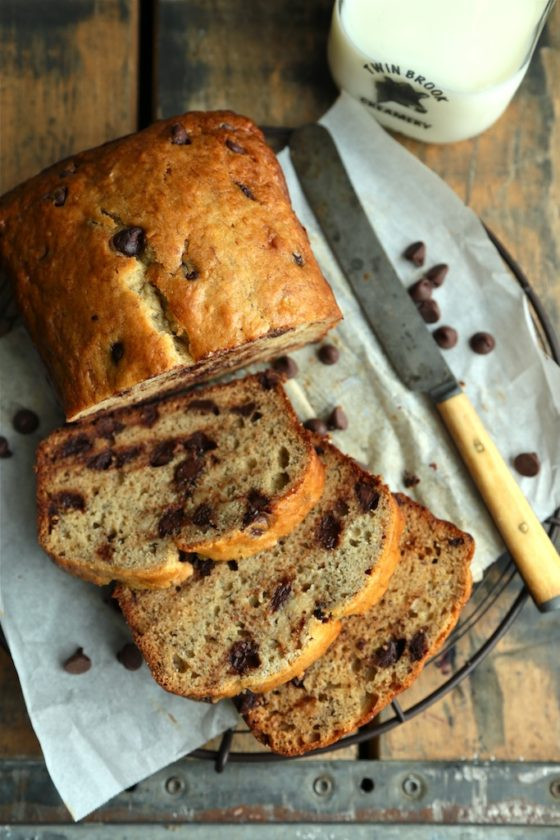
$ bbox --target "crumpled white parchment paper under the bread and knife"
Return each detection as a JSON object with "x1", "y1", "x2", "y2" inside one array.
[{"x1": 0, "y1": 96, "x2": 560, "y2": 819}]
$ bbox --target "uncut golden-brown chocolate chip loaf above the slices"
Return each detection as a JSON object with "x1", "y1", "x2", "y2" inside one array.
[{"x1": 0, "y1": 111, "x2": 341, "y2": 420}]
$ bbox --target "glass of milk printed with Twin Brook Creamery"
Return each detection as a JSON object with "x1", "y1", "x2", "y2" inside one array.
[{"x1": 328, "y1": 0, "x2": 554, "y2": 143}]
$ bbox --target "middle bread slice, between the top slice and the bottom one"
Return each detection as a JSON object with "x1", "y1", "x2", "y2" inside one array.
[{"x1": 115, "y1": 443, "x2": 401, "y2": 699}]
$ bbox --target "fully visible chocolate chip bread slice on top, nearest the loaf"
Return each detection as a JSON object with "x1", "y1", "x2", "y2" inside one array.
[{"x1": 36, "y1": 371, "x2": 324, "y2": 587}]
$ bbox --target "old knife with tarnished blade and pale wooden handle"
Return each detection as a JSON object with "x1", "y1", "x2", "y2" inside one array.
[{"x1": 290, "y1": 124, "x2": 560, "y2": 612}]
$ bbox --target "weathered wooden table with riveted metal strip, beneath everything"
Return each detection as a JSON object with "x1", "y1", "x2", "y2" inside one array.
[{"x1": 0, "y1": 0, "x2": 560, "y2": 838}]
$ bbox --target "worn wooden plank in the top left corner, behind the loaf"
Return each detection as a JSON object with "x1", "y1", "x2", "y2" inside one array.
[{"x1": 0, "y1": 0, "x2": 139, "y2": 193}]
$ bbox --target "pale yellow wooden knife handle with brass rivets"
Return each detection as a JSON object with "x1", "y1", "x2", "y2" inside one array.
[{"x1": 437, "y1": 394, "x2": 560, "y2": 612}]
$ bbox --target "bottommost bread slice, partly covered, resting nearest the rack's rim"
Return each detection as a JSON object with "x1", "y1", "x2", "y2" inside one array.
[{"x1": 243, "y1": 494, "x2": 474, "y2": 755}]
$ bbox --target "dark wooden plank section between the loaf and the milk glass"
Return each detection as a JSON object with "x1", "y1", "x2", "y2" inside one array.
[{"x1": 156, "y1": 0, "x2": 336, "y2": 126}]
